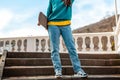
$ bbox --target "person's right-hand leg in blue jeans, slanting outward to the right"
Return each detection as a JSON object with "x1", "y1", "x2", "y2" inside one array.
[{"x1": 60, "y1": 26, "x2": 85, "y2": 74}]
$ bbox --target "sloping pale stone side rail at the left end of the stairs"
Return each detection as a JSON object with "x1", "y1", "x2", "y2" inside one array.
[{"x1": 0, "y1": 50, "x2": 7, "y2": 80}]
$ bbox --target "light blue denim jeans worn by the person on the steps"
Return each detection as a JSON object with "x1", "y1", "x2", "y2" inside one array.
[{"x1": 48, "y1": 26, "x2": 82, "y2": 72}]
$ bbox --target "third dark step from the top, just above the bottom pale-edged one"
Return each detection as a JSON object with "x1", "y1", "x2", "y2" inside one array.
[{"x1": 3, "y1": 66, "x2": 120, "y2": 77}]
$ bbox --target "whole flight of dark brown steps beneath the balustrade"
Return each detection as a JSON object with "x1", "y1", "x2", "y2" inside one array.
[{"x1": 2, "y1": 52, "x2": 120, "y2": 80}]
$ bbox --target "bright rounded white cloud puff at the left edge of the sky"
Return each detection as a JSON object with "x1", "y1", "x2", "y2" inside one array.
[{"x1": 0, "y1": 9, "x2": 13, "y2": 30}]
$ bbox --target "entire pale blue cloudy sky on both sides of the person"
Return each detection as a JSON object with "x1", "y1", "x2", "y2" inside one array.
[{"x1": 0, "y1": 0, "x2": 120, "y2": 38}]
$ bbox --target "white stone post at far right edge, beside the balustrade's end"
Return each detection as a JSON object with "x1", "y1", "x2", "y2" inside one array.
[{"x1": 115, "y1": 17, "x2": 120, "y2": 53}]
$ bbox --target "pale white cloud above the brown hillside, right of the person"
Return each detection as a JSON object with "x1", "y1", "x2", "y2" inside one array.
[{"x1": 72, "y1": 0, "x2": 114, "y2": 29}]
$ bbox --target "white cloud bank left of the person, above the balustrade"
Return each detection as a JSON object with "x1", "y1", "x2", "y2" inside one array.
[{"x1": 0, "y1": 9, "x2": 41, "y2": 37}]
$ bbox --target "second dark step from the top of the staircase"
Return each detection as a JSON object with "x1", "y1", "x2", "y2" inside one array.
[{"x1": 5, "y1": 58, "x2": 120, "y2": 66}]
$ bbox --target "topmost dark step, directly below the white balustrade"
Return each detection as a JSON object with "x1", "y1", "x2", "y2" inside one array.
[{"x1": 7, "y1": 52, "x2": 120, "y2": 59}]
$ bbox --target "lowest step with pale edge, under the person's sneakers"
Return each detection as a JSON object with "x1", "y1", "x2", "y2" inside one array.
[{"x1": 2, "y1": 74, "x2": 120, "y2": 80}]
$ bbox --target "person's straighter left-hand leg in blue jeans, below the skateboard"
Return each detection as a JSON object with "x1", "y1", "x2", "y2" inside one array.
[{"x1": 48, "y1": 26, "x2": 62, "y2": 75}]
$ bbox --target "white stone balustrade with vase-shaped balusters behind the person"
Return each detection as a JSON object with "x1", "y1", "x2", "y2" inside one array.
[{"x1": 0, "y1": 32, "x2": 116, "y2": 53}]
